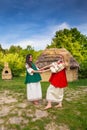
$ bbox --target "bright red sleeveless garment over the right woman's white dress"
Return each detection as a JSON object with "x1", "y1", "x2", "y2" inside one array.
[{"x1": 49, "y1": 69, "x2": 68, "y2": 88}]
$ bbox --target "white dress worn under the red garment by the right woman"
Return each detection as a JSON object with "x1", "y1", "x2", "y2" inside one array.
[{"x1": 46, "y1": 62, "x2": 65, "y2": 103}]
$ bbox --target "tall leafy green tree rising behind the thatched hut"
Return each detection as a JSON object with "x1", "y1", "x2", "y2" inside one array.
[{"x1": 47, "y1": 28, "x2": 87, "y2": 77}]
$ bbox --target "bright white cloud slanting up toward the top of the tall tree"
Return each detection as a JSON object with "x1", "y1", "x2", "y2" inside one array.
[{"x1": 15, "y1": 23, "x2": 70, "y2": 50}]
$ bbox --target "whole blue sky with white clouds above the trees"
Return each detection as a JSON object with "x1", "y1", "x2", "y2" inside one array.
[{"x1": 0, "y1": 0, "x2": 87, "y2": 50}]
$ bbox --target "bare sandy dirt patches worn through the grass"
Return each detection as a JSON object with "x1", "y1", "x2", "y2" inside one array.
[{"x1": 0, "y1": 87, "x2": 87, "y2": 130}]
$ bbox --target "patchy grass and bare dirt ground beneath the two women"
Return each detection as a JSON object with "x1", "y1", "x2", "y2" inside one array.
[{"x1": 0, "y1": 77, "x2": 87, "y2": 130}]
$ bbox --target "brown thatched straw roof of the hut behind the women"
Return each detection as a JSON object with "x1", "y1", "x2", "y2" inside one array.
[{"x1": 36, "y1": 48, "x2": 79, "y2": 69}]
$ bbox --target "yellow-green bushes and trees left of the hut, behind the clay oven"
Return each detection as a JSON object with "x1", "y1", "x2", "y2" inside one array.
[{"x1": 0, "y1": 46, "x2": 41, "y2": 77}]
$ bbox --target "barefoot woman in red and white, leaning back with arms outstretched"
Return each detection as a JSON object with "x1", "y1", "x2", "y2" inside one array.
[{"x1": 43, "y1": 55, "x2": 67, "y2": 110}]
